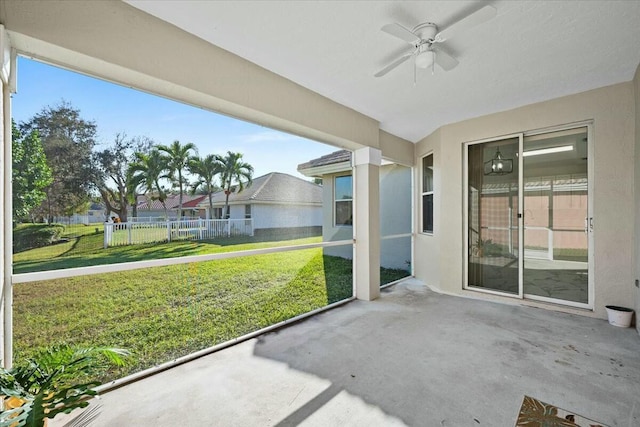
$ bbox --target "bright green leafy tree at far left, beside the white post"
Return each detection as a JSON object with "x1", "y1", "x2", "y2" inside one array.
[{"x1": 11, "y1": 120, "x2": 53, "y2": 220}]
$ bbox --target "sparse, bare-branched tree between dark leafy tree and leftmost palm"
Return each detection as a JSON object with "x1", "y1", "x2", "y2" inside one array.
[{"x1": 94, "y1": 134, "x2": 151, "y2": 222}]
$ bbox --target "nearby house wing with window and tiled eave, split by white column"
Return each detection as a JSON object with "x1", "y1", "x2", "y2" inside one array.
[{"x1": 298, "y1": 150, "x2": 411, "y2": 270}]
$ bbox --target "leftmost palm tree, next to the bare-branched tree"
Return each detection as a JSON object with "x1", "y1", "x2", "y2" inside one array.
[{"x1": 128, "y1": 149, "x2": 167, "y2": 217}]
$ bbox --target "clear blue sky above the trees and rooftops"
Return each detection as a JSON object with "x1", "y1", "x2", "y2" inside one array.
[{"x1": 12, "y1": 57, "x2": 338, "y2": 178}]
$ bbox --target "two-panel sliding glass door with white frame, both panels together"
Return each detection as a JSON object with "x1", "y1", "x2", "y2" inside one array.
[{"x1": 465, "y1": 126, "x2": 593, "y2": 307}]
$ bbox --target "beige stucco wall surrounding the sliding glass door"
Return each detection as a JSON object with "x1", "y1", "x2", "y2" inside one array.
[{"x1": 415, "y1": 82, "x2": 636, "y2": 318}]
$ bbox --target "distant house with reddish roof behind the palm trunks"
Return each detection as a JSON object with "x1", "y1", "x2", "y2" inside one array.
[{"x1": 129, "y1": 194, "x2": 207, "y2": 221}]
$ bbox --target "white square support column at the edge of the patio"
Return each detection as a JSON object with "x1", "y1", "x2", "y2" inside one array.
[{"x1": 354, "y1": 147, "x2": 382, "y2": 301}]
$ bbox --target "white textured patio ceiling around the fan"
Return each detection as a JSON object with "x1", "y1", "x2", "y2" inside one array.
[{"x1": 127, "y1": 0, "x2": 640, "y2": 142}]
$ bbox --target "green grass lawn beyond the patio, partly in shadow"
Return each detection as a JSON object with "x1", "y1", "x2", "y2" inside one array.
[{"x1": 14, "y1": 224, "x2": 407, "y2": 381}]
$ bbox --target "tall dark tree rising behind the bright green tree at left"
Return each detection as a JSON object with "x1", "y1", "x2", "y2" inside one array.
[{"x1": 18, "y1": 101, "x2": 97, "y2": 222}]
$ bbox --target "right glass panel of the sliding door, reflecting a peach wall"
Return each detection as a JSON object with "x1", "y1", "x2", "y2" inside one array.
[{"x1": 523, "y1": 127, "x2": 589, "y2": 304}]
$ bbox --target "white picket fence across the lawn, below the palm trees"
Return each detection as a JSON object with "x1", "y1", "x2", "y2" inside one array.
[{"x1": 104, "y1": 218, "x2": 253, "y2": 248}]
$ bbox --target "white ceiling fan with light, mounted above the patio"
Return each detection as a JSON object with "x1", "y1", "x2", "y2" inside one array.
[{"x1": 374, "y1": 5, "x2": 497, "y2": 77}]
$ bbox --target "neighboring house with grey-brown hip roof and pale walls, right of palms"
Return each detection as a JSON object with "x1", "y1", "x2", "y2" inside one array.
[{"x1": 197, "y1": 172, "x2": 322, "y2": 235}]
